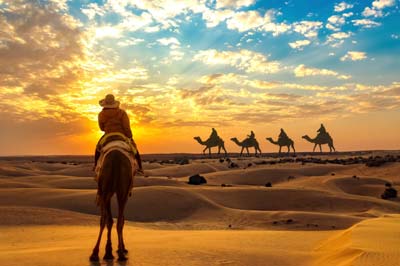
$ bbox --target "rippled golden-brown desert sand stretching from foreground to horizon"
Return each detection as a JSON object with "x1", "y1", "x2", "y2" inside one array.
[{"x1": 0, "y1": 152, "x2": 400, "y2": 266}]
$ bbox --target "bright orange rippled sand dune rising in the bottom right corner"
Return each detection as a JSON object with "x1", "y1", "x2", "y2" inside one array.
[{"x1": 315, "y1": 215, "x2": 400, "y2": 266}]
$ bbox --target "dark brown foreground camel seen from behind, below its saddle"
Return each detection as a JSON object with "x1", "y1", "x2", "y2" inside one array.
[{"x1": 90, "y1": 150, "x2": 138, "y2": 262}]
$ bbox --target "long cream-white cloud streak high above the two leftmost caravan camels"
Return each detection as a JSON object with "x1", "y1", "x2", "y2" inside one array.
[{"x1": 193, "y1": 49, "x2": 280, "y2": 73}]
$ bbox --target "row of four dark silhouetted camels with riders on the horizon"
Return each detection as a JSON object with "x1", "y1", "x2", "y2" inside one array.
[{"x1": 194, "y1": 124, "x2": 336, "y2": 156}]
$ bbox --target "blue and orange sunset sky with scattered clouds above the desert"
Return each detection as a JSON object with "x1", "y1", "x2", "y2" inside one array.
[{"x1": 0, "y1": 0, "x2": 400, "y2": 155}]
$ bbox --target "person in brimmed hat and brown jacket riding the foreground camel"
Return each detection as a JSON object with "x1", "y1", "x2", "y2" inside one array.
[{"x1": 94, "y1": 94, "x2": 143, "y2": 173}]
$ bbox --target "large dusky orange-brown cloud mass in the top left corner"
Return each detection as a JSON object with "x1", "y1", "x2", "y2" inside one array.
[{"x1": 0, "y1": 1, "x2": 85, "y2": 97}]
